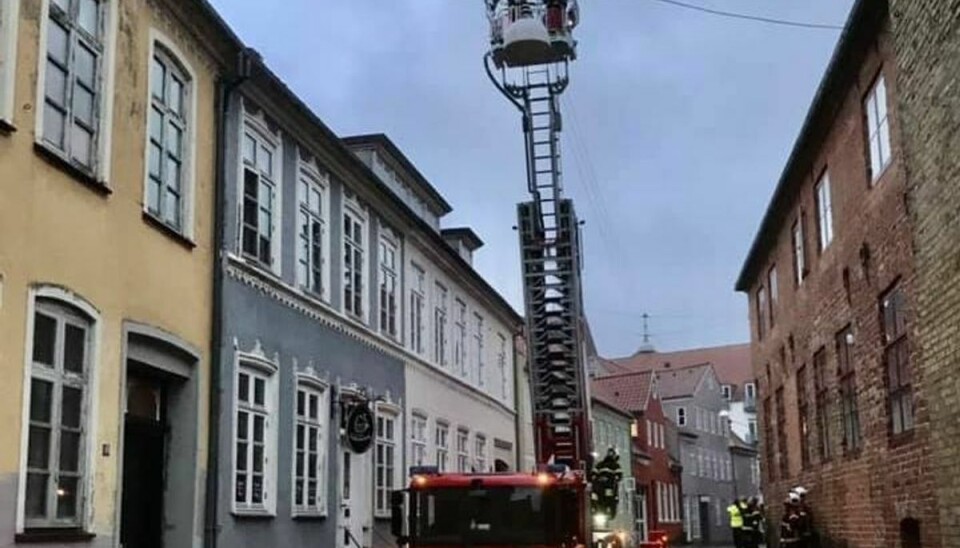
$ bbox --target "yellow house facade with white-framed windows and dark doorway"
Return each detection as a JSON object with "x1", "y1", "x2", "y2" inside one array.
[{"x1": 0, "y1": 0, "x2": 232, "y2": 547}]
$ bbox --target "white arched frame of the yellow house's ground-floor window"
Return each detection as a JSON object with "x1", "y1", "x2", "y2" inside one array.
[{"x1": 15, "y1": 294, "x2": 102, "y2": 534}]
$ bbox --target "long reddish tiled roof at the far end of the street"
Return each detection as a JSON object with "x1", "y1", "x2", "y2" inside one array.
[{"x1": 606, "y1": 343, "x2": 754, "y2": 386}]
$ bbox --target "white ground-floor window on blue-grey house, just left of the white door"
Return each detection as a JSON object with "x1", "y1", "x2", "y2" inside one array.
[{"x1": 292, "y1": 380, "x2": 329, "y2": 515}]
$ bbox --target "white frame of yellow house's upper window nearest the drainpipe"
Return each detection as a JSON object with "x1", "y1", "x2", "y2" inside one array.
[{"x1": 143, "y1": 32, "x2": 197, "y2": 235}]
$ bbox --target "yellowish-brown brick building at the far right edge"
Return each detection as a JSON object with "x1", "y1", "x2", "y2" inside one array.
[{"x1": 891, "y1": 0, "x2": 960, "y2": 546}]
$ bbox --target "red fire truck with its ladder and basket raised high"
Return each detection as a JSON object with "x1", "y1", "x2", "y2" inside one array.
[{"x1": 391, "y1": 0, "x2": 659, "y2": 548}]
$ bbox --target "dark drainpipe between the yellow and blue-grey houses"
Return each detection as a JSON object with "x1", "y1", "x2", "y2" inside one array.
[{"x1": 203, "y1": 48, "x2": 258, "y2": 548}]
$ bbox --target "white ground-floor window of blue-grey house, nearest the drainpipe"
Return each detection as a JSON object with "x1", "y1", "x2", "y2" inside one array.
[{"x1": 233, "y1": 360, "x2": 275, "y2": 513}]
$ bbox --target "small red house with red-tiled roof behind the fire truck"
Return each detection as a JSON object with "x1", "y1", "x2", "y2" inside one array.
[{"x1": 591, "y1": 372, "x2": 683, "y2": 539}]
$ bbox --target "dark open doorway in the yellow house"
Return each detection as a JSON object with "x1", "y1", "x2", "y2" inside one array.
[{"x1": 120, "y1": 371, "x2": 166, "y2": 548}]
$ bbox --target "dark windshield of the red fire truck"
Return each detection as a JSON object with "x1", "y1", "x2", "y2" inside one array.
[{"x1": 413, "y1": 486, "x2": 577, "y2": 546}]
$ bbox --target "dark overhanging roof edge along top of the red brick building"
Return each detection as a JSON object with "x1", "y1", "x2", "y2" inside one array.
[{"x1": 735, "y1": 0, "x2": 888, "y2": 291}]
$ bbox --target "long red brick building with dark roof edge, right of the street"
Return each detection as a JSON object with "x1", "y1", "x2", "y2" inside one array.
[{"x1": 736, "y1": 0, "x2": 940, "y2": 547}]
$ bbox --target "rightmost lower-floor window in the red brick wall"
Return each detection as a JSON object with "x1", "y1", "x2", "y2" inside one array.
[{"x1": 880, "y1": 286, "x2": 913, "y2": 434}]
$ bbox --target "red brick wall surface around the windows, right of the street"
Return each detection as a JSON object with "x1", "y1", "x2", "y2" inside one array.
[{"x1": 750, "y1": 10, "x2": 940, "y2": 548}]
